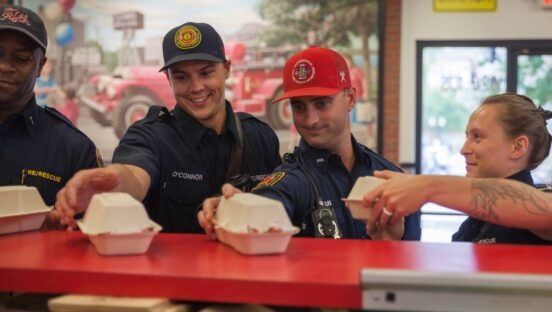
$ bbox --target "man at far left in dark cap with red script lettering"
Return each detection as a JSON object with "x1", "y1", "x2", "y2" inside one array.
[{"x1": 0, "y1": 5, "x2": 101, "y2": 219}]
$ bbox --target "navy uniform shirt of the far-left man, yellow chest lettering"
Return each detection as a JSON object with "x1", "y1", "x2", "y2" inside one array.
[{"x1": 0, "y1": 96, "x2": 101, "y2": 206}]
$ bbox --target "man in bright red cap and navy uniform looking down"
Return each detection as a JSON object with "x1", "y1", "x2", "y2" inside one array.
[{"x1": 198, "y1": 47, "x2": 421, "y2": 240}]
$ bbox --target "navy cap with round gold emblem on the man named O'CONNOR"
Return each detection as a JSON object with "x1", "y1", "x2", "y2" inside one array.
[{"x1": 159, "y1": 22, "x2": 226, "y2": 71}]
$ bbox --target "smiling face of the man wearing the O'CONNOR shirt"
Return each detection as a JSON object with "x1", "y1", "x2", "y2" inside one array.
[{"x1": 167, "y1": 61, "x2": 230, "y2": 133}]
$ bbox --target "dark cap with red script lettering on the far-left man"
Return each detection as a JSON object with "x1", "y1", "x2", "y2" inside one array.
[{"x1": 0, "y1": 5, "x2": 48, "y2": 51}]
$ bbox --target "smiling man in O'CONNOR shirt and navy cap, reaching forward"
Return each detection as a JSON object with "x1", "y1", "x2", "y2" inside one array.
[{"x1": 56, "y1": 22, "x2": 281, "y2": 233}]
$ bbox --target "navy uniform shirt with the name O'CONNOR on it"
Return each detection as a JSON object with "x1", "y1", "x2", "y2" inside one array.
[{"x1": 113, "y1": 102, "x2": 281, "y2": 233}]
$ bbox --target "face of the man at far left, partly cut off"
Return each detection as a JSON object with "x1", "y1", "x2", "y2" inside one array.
[{"x1": 0, "y1": 30, "x2": 45, "y2": 120}]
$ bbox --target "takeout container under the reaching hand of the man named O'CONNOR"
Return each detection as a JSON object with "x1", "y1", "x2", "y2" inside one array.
[{"x1": 77, "y1": 193, "x2": 161, "y2": 255}]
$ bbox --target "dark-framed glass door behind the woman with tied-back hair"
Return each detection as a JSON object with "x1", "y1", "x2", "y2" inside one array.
[{"x1": 415, "y1": 40, "x2": 552, "y2": 241}]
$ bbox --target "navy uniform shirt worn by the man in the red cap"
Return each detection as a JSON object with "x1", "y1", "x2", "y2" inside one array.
[{"x1": 254, "y1": 136, "x2": 422, "y2": 240}]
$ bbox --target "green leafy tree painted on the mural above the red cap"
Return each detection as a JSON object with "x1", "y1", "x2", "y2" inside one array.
[{"x1": 258, "y1": 0, "x2": 379, "y2": 99}]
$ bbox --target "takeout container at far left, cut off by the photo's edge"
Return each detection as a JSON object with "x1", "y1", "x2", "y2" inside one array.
[{"x1": 0, "y1": 185, "x2": 50, "y2": 234}]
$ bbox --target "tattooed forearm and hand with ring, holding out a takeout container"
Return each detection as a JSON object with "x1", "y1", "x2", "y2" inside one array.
[{"x1": 364, "y1": 171, "x2": 552, "y2": 238}]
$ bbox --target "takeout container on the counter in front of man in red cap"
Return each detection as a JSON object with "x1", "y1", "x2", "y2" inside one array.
[{"x1": 215, "y1": 193, "x2": 299, "y2": 255}]
